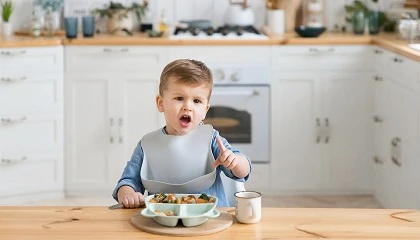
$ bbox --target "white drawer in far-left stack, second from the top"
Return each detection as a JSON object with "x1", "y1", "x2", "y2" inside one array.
[{"x1": 0, "y1": 73, "x2": 63, "y2": 114}]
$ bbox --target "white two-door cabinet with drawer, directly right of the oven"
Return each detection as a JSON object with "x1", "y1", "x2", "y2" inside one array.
[{"x1": 271, "y1": 46, "x2": 372, "y2": 193}]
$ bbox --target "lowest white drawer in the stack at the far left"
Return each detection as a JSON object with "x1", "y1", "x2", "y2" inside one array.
[{"x1": 0, "y1": 151, "x2": 63, "y2": 197}]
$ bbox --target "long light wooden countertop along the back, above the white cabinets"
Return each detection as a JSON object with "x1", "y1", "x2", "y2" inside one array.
[{"x1": 0, "y1": 32, "x2": 420, "y2": 61}]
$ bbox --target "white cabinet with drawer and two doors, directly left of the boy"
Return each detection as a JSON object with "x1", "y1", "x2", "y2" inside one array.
[{"x1": 66, "y1": 46, "x2": 165, "y2": 195}]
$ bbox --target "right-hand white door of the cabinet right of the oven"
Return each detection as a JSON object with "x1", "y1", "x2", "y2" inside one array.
[{"x1": 320, "y1": 72, "x2": 372, "y2": 192}]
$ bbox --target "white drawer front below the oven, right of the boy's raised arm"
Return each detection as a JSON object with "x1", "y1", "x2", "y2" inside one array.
[{"x1": 245, "y1": 163, "x2": 270, "y2": 191}]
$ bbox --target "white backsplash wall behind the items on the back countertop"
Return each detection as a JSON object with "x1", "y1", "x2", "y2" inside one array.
[{"x1": 5, "y1": 0, "x2": 404, "y2": 29}]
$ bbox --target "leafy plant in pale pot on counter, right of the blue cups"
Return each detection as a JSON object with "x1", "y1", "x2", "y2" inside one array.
[{"x1": 93, "y1": 1, "x2": 148, "y2": 35}]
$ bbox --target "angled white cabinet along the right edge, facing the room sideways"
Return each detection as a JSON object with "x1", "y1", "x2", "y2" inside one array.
[{"x1": 373, "y1": 48, "x2": 420, "y2": 208}]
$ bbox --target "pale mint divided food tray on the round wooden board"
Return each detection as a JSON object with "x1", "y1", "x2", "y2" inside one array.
[{"x1": 140, "y1": 194, "x2": 220, "y2": 227}]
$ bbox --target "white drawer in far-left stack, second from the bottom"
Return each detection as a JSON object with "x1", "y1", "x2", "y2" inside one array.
[{"x1": 0, "y1": 113, "x2": 63, "y2": 153}]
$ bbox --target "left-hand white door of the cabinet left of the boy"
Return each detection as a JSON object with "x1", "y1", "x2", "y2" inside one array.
[{"x1": 66, "y1": 74, "x2": 116, "y2": 192}]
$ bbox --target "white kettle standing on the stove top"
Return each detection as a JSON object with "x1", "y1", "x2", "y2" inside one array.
[{"x1": 225, "y1": 0, "x2": 255, "y2": 26}]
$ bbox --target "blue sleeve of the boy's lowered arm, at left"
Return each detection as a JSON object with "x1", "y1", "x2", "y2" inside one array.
[{"x1": 112, "y1": 142, "x2": 144, "y2": 201}]
